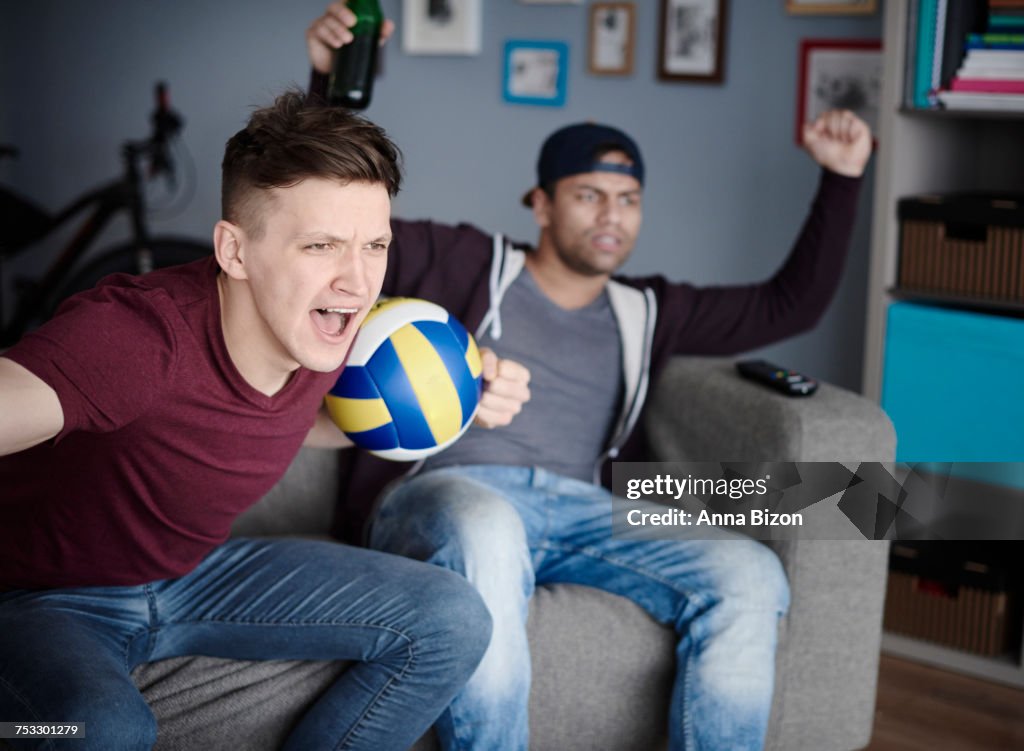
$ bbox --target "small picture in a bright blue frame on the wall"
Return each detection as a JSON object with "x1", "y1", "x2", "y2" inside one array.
[{"x1": 502, "y1": 39, "x2": 569, "y2": 107}]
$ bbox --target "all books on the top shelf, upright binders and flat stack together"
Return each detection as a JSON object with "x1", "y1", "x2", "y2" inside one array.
[{"x1": 903, "y1": 0, "x2": 1024, "y2": 112}]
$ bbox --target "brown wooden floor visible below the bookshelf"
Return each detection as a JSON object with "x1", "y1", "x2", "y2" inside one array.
[{"x1": 867, "y1": 655, "x2": 1024, "y2": 751}]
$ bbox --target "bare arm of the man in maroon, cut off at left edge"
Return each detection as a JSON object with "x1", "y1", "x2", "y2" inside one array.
[{"x1": 0, "y1": 358, "x2": 63, "y2": 456}]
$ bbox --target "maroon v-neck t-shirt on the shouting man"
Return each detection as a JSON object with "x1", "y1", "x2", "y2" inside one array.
[{"x1": 0, "y1": 258, "x2": 340, "y2": 588}]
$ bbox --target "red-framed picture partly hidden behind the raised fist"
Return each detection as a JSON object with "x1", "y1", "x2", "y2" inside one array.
[{"x1": 796, "y1": 39, "x2": 882, "y2": 144}]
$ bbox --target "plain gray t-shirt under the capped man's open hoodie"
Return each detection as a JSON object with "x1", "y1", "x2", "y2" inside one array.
[{"x1": 424, "y1": 269, "x2": 623, "y2": 482}]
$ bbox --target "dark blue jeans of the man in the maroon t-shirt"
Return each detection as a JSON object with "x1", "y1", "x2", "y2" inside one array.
[{"x1": 0, "y1": 540, "x2": 490, "y2": 751}]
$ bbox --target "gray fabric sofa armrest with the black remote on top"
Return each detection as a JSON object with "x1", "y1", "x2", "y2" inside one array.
[{"x1": 645, "y1": 358, "x2": 896, "y2": 749}]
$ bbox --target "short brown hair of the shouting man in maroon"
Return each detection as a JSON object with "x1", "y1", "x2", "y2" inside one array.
[{"x1": 220, "y1": 90, "x2": 401, "y2": 237}]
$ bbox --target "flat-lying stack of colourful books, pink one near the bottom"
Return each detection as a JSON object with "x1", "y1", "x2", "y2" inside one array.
[{"x1": 937, "y1": 0, "x2": 1024, "y2": 112}]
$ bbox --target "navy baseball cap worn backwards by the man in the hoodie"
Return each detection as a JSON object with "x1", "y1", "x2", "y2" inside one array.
[{"x1": 522, "y1": 123, "x2": 643, "y2": 206}]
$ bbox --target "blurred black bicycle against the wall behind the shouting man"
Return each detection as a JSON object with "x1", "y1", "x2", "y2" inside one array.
[{"x1": 0, "y1": 83, "x2": 213, "y2": 348}]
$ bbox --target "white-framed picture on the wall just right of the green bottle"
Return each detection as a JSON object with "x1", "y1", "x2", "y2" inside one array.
[{"x1": 401, "y1": 0, "x2": 483, "y2": 54}]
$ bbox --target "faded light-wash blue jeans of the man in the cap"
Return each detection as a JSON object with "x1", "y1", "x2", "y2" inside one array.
[{"x1": 371, "y1": 466, "x2": 788, "y2": 751}]
